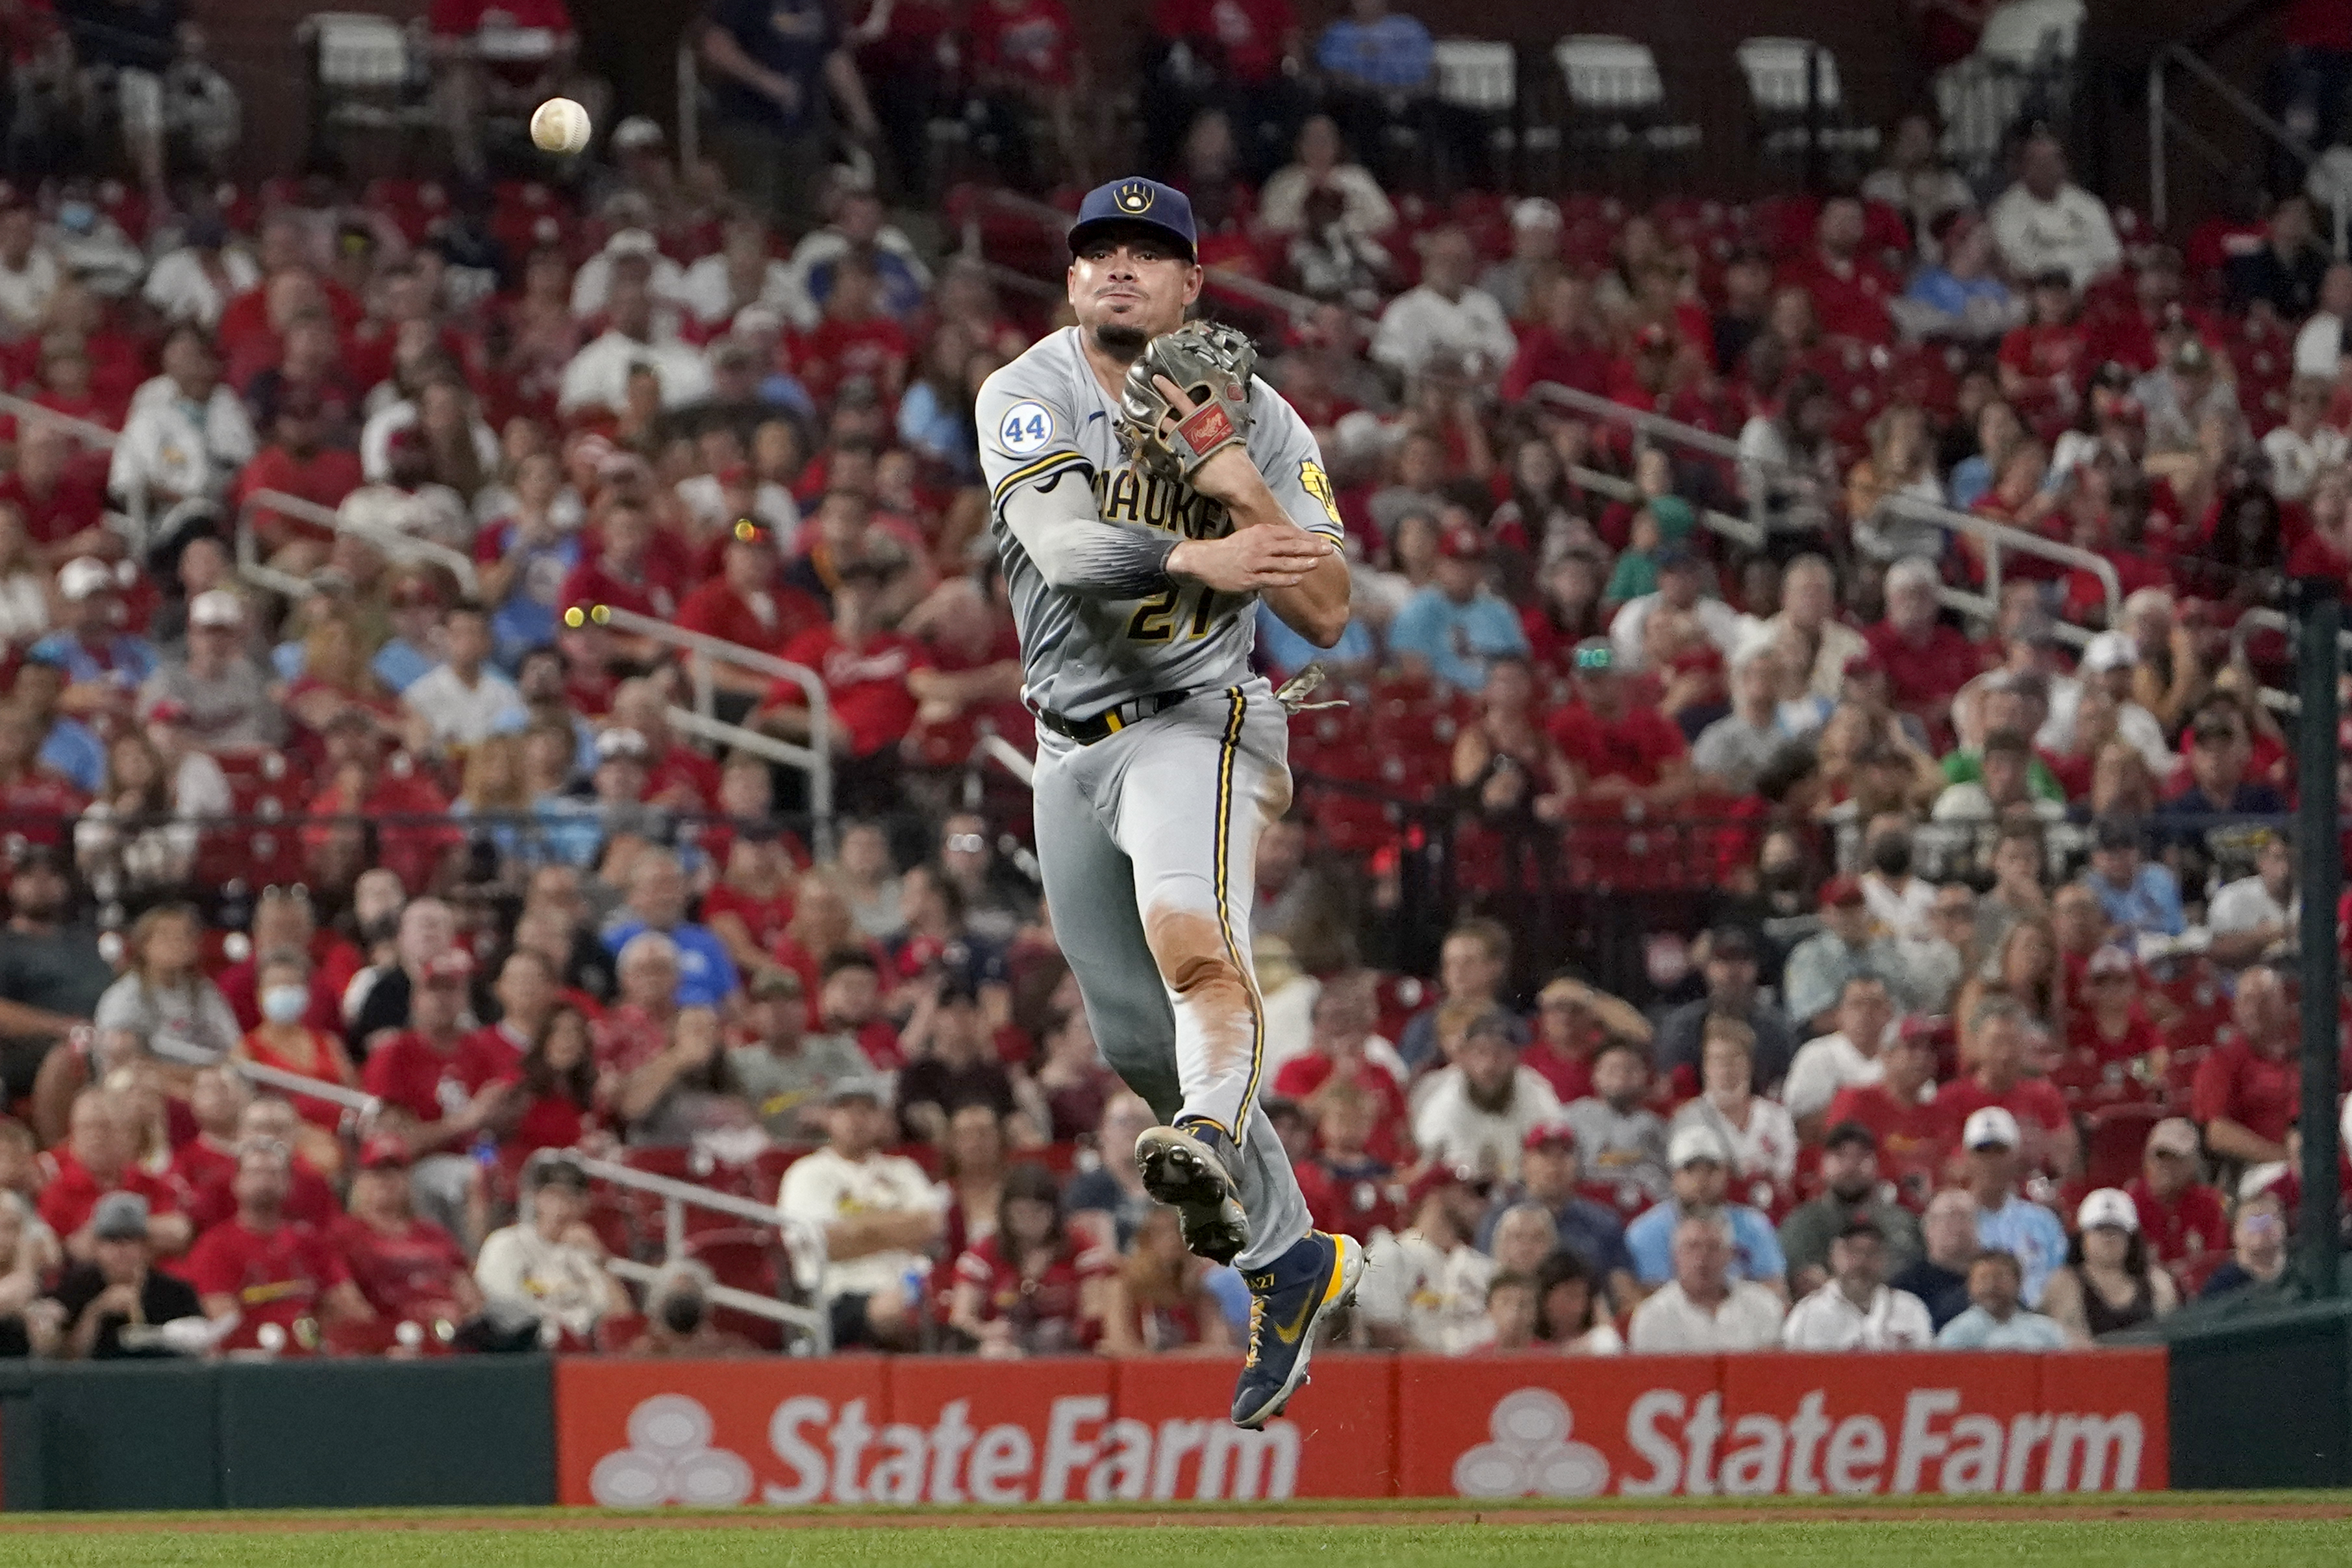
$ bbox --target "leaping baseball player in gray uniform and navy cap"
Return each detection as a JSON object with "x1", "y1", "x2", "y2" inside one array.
[{"x1": 976, "y1": 179, "x2": 1364, "y2": 1427}]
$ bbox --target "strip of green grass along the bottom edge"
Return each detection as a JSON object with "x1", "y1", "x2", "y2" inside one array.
[{"x1": 14, "y1": 1493, "x2": 2352, "y2": 1568}]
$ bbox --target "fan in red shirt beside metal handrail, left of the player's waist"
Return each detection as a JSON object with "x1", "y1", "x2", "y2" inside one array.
[{"x1": 755, "y1": 560, "x2": 931, "y2": 797}]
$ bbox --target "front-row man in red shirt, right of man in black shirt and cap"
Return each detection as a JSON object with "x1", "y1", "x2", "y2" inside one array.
[{"x1": 186, "y1": 1145, "x2": 377, "y2": 1349}]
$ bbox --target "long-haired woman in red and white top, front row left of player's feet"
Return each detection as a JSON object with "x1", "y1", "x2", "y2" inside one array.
[{"x1": 948, "y1": 1164, "x2": 1120, "y2": 1356}]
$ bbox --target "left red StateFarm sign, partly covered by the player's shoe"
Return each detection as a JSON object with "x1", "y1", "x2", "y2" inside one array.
[{"x1": 555, "y1": 1354, "x2": 1395, "y2": 1507}]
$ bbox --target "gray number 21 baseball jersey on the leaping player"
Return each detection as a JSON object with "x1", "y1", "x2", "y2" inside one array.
[{"x1": 976, "y1": 327, "x2": 1343, "y2": 719}]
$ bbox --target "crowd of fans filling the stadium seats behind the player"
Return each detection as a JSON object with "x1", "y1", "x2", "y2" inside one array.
[{"x1": 0, "y1": 0, "x2": 2352, "y2": 1356}]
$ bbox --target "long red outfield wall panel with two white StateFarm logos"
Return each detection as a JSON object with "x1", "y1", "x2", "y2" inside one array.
[{"x1": 555, "y1": 1349, "x2": 2168, "y2": 1507}]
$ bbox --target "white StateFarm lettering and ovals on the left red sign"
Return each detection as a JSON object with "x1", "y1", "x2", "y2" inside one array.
[{"x1": 588, "y1": 1394, "x2": 1301, "y2": 1509}]
